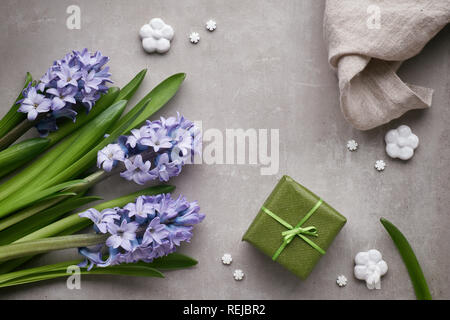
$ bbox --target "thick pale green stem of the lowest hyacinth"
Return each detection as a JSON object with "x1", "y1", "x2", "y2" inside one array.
[{"x1": 0, "y1": 234, "x2": 109, "y2": 262}]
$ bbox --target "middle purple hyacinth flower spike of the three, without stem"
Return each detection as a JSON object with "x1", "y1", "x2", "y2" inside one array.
[{"x1": 97, "y1": 114, "x2": 201, "y2": 184}]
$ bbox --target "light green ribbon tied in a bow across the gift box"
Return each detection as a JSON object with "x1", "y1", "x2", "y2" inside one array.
[{"x1": 261, "y1": 199, "x2": 325, "y2": 261}]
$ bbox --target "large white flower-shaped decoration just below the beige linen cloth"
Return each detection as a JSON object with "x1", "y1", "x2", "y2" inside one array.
[{"x1": 384, "y1": 125, "x2": 419, "y2": 160}]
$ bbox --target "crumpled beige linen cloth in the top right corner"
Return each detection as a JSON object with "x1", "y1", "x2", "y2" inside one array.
[{"x1": 324, "y1": 0, "x2": 450, "y2": 130}]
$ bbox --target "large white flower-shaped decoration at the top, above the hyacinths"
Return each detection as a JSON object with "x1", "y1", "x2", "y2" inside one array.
[{"x1": 139, "y1": 18, "x2": 175, "y2": 53}]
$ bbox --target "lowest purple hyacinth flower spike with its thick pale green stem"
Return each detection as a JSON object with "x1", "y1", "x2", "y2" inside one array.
[{"x1": 0, "y1": 194, "x2": 205, "y2": 270}]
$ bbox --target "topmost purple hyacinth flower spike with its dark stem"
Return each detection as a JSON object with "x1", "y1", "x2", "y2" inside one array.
[{"x1": 0, "y1": 48, "x2": 112, "y2": 150}]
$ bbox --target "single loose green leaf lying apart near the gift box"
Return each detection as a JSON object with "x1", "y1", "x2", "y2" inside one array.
[{"x1": 380, "y1": 218, "x2": 432, "y2": 300}]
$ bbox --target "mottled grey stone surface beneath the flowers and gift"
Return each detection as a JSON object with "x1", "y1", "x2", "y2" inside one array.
[{"x1": 0, "y1": 0, "x2": 450, "y2": 299}]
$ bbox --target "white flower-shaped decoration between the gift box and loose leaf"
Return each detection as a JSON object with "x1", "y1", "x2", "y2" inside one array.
[{"x1": 354, "y1": 249, "x2": 388, "y2": 290}]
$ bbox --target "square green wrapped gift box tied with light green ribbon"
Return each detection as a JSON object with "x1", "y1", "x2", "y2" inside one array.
[{"x1": 242, "y1": 176, "x2": 347, "y2": 279}]
